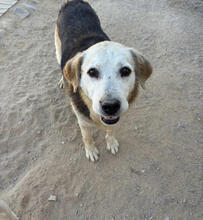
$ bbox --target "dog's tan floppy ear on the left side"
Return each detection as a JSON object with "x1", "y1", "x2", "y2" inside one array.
[{"x1": 63, "y1": 53, "x2": 83, "y2": 93}]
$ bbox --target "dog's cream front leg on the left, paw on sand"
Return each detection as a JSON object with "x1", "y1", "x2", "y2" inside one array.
[{"x1": 80, "y1": 125, "x2": 99, "y2": 162}]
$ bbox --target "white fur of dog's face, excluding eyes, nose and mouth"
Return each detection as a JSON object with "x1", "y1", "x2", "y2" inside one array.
[{"x1": 80, "y1": 41, "x2": 135, "y2": 122}]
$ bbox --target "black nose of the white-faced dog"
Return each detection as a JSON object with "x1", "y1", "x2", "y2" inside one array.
[{"x1": 100, "y1": 99, "x2": 121, "y2": 115}]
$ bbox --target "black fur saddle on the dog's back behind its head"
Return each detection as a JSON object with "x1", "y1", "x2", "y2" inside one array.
[{"x1": 57, "y1": 0, "x2": 109, "y2": 69}]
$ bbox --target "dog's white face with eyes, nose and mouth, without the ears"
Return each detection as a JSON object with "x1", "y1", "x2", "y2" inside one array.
[{"x1": 80, "y1": 42, "x2": 135, "y2": 125}]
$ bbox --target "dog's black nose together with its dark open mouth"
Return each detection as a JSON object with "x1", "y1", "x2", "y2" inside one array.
[{"x1": 100, "y1": 99, "x2": 121, "y2": 125}]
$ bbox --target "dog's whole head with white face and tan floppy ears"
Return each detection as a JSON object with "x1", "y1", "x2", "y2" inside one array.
[{"x1": 63, "y1": 41, "x2": 152, "y2": 125}]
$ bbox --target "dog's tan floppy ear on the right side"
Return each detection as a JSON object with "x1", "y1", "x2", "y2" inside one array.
[{"x1": 131, "y1": 49, "x2": 152, "y2": 89}]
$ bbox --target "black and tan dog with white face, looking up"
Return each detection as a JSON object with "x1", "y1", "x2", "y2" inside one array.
[{"x1": 55, "y1": 0, "x2": 152, "y2": 162}]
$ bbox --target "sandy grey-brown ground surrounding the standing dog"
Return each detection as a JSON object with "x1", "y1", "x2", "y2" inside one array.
[{"x1": 0, "y1": 0, "x2": 203, "y2": 220}]
